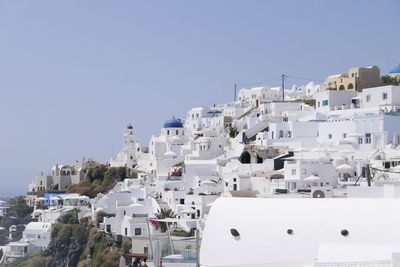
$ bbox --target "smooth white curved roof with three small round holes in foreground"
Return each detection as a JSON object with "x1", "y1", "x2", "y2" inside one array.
[{"x1": 200, "y1": 198, "x2": 400, "y2": 266}]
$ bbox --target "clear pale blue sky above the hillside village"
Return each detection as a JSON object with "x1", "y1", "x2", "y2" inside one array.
[{"x1": 0, "y1": 0, "x2": 400, "y2": 195}]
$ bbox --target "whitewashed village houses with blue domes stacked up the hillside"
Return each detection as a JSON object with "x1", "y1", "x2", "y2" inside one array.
[{"x1": 11, "y1": 63, "x2": 400, "y2": 264}]
